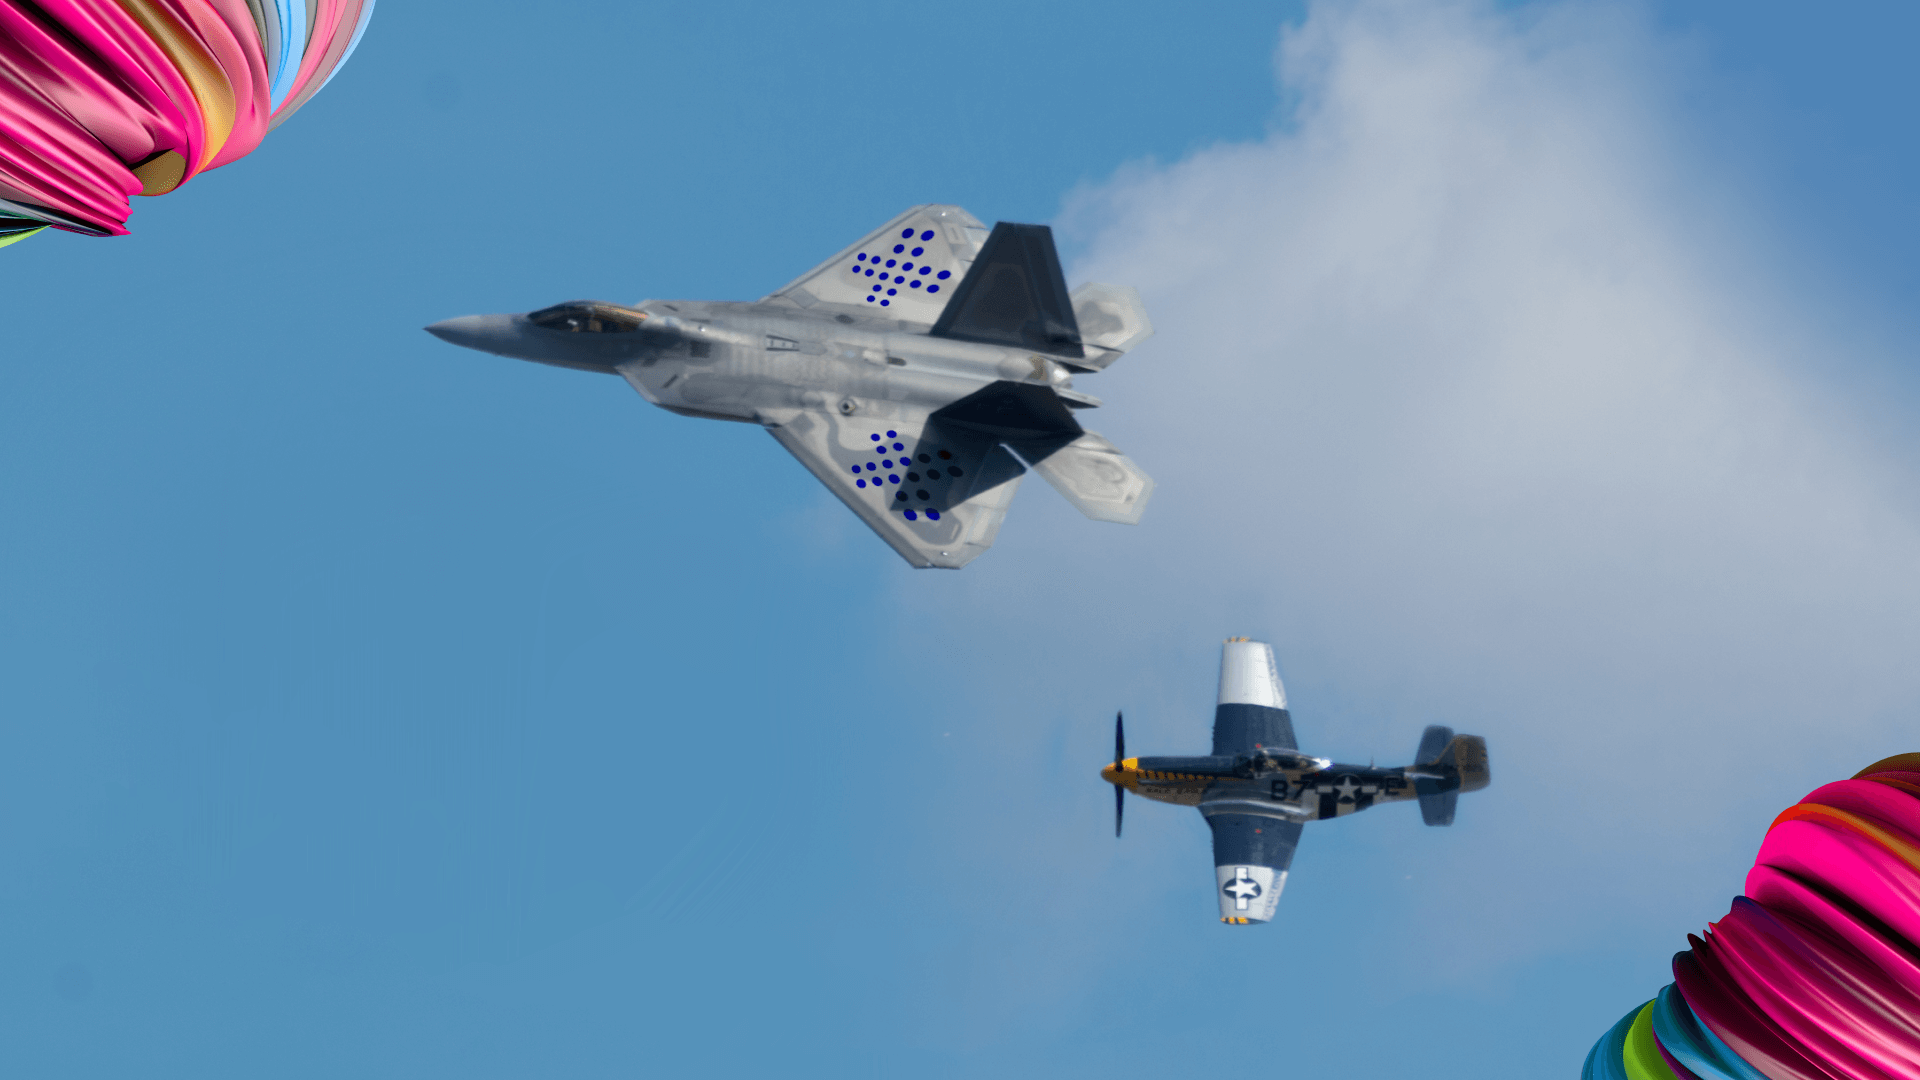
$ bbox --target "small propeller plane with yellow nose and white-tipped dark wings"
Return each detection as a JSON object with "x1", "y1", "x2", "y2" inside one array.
[{"x1": 1100, "y1": 638, "x2": 1490, "y2": 926}]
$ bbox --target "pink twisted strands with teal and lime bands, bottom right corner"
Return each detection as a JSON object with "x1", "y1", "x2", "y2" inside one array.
[{"x1": 1582, "y1": 753, "x2": 1920, "y2": 1080}]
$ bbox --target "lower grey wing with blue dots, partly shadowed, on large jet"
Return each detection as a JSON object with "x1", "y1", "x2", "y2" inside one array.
[{"x1": 766, "y1": 409, "x2": 1025, "y2": 569}]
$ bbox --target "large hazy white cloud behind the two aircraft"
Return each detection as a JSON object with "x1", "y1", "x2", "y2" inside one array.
[{"x1": 910, "y1": 0, "x2": 1920, "y2": 991}]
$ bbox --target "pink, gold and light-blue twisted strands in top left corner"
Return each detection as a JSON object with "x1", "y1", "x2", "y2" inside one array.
[{"x1": 0, "y1": 0, "x2": 374, "y2": 246}]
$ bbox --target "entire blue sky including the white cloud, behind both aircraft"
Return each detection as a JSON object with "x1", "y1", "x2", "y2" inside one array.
[{"x1": 0, "y1": 0, "x2": 1920, "y2": 1078}]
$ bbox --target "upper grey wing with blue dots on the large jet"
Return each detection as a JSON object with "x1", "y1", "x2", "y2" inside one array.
[{"x1": 760, "y1": 206, "x2": 987, "y2": 319}]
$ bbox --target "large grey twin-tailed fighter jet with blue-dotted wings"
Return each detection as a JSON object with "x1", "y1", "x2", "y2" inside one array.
[{"x1": 426, "y1": 206, "x2": 1154, "y2": 569}]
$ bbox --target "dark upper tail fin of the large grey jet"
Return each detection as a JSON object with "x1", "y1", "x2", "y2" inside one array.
[{"x1": 927, "y1": 221, "x2": 1085, "y2": 359}]
